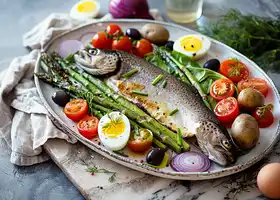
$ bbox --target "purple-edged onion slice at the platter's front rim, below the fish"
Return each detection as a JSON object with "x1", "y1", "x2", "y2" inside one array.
[{"x1": 170, "y1": 151, "x2": 211, "y2": 172}]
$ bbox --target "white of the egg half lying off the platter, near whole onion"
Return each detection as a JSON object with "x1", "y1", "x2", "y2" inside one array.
[{"x1": 70, "y1": 0, "x2": 100, "y2": 20}]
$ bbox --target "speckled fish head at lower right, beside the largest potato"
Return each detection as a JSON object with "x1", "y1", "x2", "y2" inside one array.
[{"x1": 196, "y1": 121, "x2": 236, "y2": 166}]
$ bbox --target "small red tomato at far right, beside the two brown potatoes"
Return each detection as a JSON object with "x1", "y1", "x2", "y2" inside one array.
[{"x1": 252, "y1": 104, "x2": 274, "y2": 128}]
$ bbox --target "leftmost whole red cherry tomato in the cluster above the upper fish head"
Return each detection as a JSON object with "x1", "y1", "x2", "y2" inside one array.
[{"x1": 92, "y1": 32, "x2": 112, "y2": 49}]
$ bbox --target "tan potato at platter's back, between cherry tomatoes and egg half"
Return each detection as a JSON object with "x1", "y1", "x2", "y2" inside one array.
[{"x1": 140, "y1": 24, "x2": 169, "y2": 45}]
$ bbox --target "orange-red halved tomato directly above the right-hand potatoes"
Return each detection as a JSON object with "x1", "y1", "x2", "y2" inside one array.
[{"x1": 237, "y1": 78, "x2": 268, "y2": 97}]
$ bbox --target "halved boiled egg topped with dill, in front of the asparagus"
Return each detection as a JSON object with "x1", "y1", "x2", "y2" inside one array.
[{"x1": 98, "y1": 112, "x2": 130, "y2": 151}]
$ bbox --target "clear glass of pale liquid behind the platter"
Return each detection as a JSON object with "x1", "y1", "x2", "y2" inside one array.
[{"x1": 165, "y1": 0, "x2": 203, "y2": 23}]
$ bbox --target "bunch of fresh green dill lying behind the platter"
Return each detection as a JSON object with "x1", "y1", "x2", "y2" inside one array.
[{"x1": 198, "y1": 9, "x2": 280, "y2": 72}]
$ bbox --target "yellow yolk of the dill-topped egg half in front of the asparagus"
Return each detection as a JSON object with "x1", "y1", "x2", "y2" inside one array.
[{"x1": 102, "y1": 121, "x2": 125, "y2": 138}]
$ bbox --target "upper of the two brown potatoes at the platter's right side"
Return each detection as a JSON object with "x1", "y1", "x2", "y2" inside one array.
[{"x1": 237, "y1": 88, "x2": 265, "y2": 111}]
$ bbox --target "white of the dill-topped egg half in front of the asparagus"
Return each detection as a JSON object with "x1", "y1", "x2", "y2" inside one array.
[{"x1": 98, "y1": 112, "x2": 130, "y2": 151}]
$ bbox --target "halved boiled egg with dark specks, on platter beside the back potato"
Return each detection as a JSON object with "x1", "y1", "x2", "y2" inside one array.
[{"x1": 173, "y1": 35, "x2": 211, "y2": 60}]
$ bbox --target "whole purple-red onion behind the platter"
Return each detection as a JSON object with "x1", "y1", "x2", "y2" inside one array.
[{"x1": 109, "y1": 0, "x2": 154, "y2": 19}]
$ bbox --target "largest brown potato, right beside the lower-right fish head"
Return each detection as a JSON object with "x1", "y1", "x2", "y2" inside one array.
[{"x1": 231, "y1": 114, "x2": 260, "y2": 150}]
